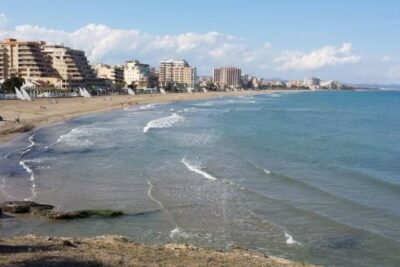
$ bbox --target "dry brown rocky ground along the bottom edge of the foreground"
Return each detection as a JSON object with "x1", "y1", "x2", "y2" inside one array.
[{"x1": 0, "y1": 236, "x2": 312, "y2": 267}]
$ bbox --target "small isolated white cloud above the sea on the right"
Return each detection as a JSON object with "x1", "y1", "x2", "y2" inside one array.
[{"x1": 274, "y1": 43, "x2": 361, "y2": 70}]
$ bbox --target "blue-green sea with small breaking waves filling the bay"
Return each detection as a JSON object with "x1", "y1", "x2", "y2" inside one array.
[{"x1": 0, "y1": 91, "x2": 400, "y2": 266}]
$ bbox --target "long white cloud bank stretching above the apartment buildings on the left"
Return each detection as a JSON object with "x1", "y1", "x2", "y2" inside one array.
[{"x1": 0, "y1": 24, "x2": 250, "y2": 67}]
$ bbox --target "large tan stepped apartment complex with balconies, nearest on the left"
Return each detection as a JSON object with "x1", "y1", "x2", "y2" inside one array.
[{"x1": 0, "y1": 39, "x2": 102, "y2": 89}]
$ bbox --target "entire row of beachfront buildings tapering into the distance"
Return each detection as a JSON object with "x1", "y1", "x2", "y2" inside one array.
[{"x1": 0, "y1": 39, "x2": 342, "y2": 89}]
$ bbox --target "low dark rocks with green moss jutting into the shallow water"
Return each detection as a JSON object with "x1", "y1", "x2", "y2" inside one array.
[{"x1": 0, "y1": 201, "x2": 124, "y2": 220}]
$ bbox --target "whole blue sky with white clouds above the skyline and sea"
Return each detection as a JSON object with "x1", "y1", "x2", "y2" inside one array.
[{"x1": 0, "y1": 0, "x2": 400, "y2": 84}]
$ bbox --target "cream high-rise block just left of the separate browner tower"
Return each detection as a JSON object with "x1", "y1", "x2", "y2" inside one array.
[{"x1": 159, "y1": 60, "x2": 196, "y2": 87}]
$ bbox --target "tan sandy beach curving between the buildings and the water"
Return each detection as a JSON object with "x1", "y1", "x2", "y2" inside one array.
[{"x1": 0, "y1": 90, "x2": 307, "y2": 144}]
